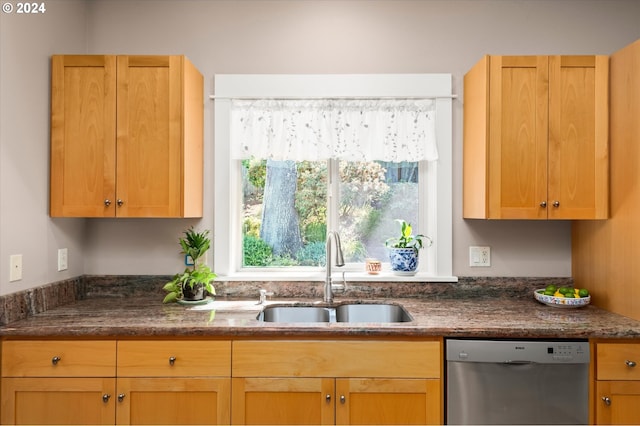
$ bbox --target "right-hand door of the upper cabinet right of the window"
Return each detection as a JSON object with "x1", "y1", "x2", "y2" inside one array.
[{"x1": 547, "y1": 56, "x2": 609, "y2": 219}]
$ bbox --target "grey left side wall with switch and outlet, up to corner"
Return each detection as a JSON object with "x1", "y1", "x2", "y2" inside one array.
[{"x1": 0, "y1": 0, "x2": 88, "y2": 294}]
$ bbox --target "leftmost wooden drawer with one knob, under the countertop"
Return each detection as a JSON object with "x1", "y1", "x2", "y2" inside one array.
[{"x1": 2, "y1": 340, "x2": 116, "y2": 377}]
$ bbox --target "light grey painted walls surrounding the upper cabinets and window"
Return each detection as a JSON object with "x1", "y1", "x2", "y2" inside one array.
[{"x1": 0, "y1": 0, "x2": 640, "y2": 294}]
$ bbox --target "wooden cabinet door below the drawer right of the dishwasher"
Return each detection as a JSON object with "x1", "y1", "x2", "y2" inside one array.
[{"x1": 595, "y1": 380, "x2": 640, "y2": 425}]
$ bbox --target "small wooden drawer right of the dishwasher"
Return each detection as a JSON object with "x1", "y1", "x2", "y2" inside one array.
[{"x1": 596, "y1": 343, "x2": 640, "y2": 380}]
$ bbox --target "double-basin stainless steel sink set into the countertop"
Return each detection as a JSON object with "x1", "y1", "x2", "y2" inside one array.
[{"x1": 258, "y1": 303, "x2": 413, "y2": 323}]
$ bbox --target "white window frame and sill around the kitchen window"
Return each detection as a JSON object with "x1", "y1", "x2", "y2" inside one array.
[{"x1": 212, "y1": 74, "x2": 457, "y2": 282}]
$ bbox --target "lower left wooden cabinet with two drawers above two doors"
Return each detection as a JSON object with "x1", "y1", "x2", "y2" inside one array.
[{"x1": 0, "y1": 340, "x2": 231, "y2": 425}]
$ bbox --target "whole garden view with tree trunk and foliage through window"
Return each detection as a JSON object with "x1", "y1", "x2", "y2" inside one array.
[{"x1": 242, "y1": 159, "x2": 419, "y2": 267}]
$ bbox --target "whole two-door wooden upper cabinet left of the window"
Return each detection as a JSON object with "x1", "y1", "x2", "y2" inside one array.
[{"x1": 50, "y1": 55, "x2": 204, "y2": 217}]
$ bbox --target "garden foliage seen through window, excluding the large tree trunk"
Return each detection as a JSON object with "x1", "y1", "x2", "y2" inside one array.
[{"x1": 243, "y1": 160, "x2": 417, "y2": 266}]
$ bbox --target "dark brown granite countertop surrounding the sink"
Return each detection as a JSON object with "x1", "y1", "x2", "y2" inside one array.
[{"x1": 0, "y1": 295, "x2": 640, "y2": 339}]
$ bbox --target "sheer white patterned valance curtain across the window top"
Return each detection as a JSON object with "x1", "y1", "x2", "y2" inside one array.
[{"x1": 230, "y1": 99, "x2": 438, "y2": 162}]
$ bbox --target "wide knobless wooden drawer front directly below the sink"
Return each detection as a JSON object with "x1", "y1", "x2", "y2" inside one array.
[{"x1": 233, "y1": 341, "x2": 441, "y2": 379}]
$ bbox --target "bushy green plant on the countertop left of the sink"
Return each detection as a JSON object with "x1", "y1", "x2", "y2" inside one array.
[{"x1": 163, "y1": 227, "x2": 216, "y2": 303}]
